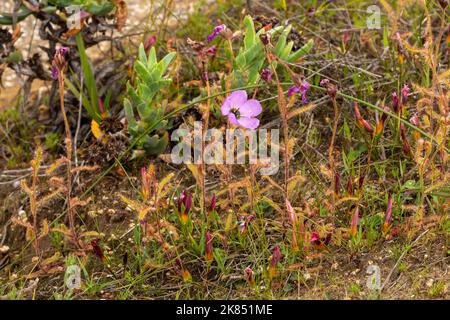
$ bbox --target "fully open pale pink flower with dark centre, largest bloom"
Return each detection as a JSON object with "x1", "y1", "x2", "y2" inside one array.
[{"x1": 221, "y1": 90, "x2": 262, "y2": 129}]
